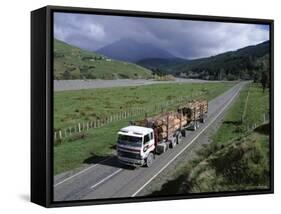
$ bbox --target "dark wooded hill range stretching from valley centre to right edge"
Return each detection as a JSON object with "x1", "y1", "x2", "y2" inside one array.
[{"x1": 137, "y1": 41, "x2": 270, "y2": 80}]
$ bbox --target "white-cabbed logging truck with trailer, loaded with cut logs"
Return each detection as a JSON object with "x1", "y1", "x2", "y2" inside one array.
[{"x1": 117, "y1": 100, "x2": 208, "y2": 167}]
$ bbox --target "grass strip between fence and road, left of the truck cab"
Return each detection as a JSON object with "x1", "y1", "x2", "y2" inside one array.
[{"x1": 54, "y1": 118, "x2": 133, "y2": 174}]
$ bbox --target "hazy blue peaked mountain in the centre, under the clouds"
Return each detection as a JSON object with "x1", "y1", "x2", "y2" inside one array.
[{"x1": 96, "y1": 38, "x2": 176, "y2": 62}]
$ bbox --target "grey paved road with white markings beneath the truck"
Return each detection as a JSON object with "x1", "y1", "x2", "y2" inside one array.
[{"x1": 54, "y1": 82, "x2": 246, "y2": 201}]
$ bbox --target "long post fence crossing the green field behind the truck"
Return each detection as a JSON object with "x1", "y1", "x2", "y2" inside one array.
[{"x1": 53, "y1": 92, "x2": 203, "y2": 142}]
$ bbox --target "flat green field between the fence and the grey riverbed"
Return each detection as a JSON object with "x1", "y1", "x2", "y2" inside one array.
[{"x1": 54, "y1": 82, "x2": 234, "y2": 130}]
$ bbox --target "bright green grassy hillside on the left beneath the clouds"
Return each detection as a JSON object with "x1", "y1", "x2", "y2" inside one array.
[{"x1": 54, "y1": 39, "x2": 152, "y2": 80}]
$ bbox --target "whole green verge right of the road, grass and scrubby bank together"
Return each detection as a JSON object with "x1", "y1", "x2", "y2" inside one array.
[{"x1": 148, "y1": 83, "x2": 270, "y2": 196}]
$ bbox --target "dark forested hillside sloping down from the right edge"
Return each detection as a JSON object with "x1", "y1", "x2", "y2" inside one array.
[{"x1": 177, "y1": 41, "x2": 269, "y2": 80}]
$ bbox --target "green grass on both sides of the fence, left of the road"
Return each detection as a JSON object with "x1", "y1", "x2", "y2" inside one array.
[{"x1": 54, "y1": 83, "x2": 234, "y2": 174}]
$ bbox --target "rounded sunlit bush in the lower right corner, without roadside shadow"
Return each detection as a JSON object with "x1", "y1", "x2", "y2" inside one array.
[{"x1": 181, "y1": 134, "x2": 269, "y2": 192}]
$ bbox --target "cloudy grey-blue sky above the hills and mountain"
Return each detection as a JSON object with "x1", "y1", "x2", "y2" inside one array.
[{"x1": 54, "y1": 13, "x2": 269, "y2": 59}]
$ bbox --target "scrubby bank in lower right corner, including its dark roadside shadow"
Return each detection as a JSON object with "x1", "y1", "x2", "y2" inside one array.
[{"x1": 150, "y1": 132, "x2": 270, "y2": 196}]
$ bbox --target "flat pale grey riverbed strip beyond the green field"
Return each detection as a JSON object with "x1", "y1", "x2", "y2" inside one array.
[{"x1": 54, "y1": 78, "x2": 225, "y2": 91}]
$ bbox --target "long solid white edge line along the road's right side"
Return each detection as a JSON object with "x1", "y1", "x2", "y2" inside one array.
[{"x1": 131, "y1": 86, "x2": 241, "y2": 197}]
